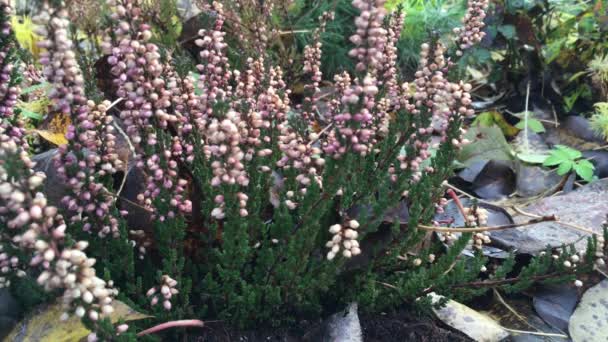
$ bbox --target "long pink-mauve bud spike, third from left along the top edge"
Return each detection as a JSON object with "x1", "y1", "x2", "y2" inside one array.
[{"x1": 104, "y1": 0, "x2": 192, "y2": 220}]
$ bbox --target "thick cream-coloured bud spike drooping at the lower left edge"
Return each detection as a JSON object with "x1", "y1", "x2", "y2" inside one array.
[{"x1": 0, "y1": 129, "x2": 116, "y2": 320}]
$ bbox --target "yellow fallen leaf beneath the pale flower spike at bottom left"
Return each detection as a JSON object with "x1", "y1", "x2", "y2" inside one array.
[{"x1": 5, "y1": 300, "x2": 152, "y2": 342}]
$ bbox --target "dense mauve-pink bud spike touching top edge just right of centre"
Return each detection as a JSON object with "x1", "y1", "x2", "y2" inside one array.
[{"x1": 349, "y1": 0, "x2": 387, "y2": 71}]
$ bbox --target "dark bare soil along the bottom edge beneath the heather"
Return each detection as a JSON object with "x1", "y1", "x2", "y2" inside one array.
[{"x1": 192, "y1": 311, "x2": 472, "y2": 342}]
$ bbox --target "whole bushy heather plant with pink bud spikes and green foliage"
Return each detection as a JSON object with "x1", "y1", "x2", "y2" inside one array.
[{"x1": 0, "y1": 0, "x2": 603, "y2": 340}]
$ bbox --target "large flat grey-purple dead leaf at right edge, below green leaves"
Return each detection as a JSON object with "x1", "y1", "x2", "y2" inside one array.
[{"x1": 491, "y1": 180, "x2": 608, "y2": 254}]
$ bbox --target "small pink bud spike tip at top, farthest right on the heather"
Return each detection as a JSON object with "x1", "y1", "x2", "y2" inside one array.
[{"x1": 454, "y1": 0, "x2": 490, "y2": 54}]
